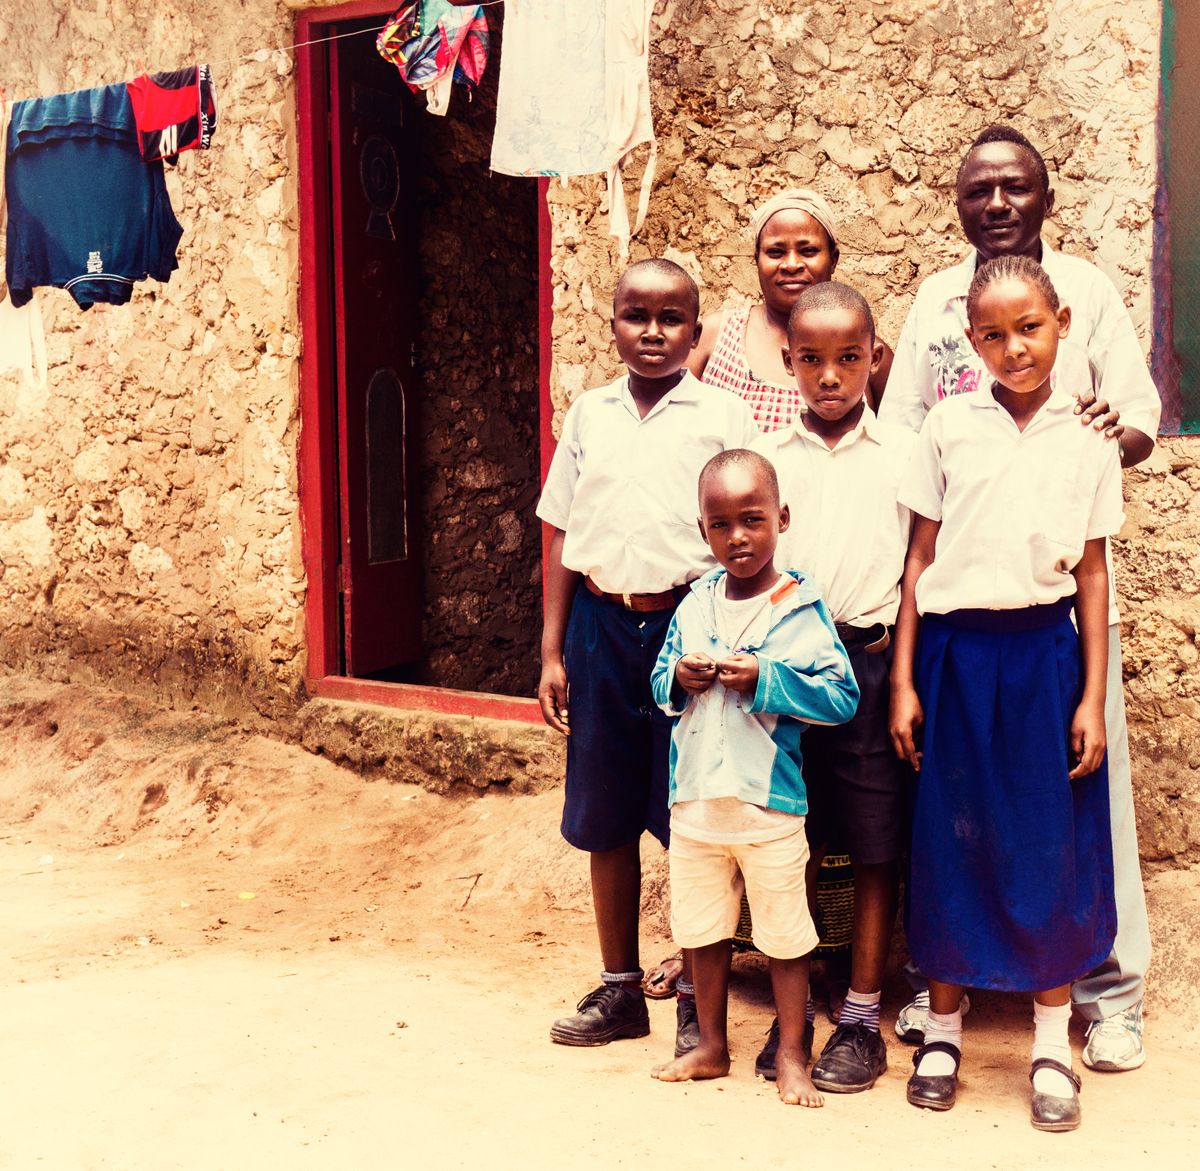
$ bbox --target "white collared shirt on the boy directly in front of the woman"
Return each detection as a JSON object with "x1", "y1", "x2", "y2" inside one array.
[{"x1": 751, "y1": 406, "x2": 917, "y2": 626}]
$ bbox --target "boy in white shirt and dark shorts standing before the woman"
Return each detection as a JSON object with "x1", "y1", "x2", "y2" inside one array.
[{"x1": 752, "y1": 282, "x2": 914, "y2": 1093}]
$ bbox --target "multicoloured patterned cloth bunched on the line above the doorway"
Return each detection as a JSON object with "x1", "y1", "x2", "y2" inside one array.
[{"x1": 376, "y1": 0, "x2": 488, "y2": 114}]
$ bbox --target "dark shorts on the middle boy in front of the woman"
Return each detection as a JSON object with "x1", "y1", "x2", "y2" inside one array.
[{"x1": 800, "y1": 643, "x2": 911, "y2": 866}]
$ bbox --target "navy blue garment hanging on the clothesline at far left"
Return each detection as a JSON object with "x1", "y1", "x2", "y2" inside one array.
[{"x1": 4, "y1": 84, "x2": 184, "y2": 308}]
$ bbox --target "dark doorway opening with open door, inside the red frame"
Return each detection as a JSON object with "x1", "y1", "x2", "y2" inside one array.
[{"x1": 306, "y1": 6, "x2": 541, "y2": 695}]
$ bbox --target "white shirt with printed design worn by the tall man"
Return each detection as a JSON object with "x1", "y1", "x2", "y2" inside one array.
[{"x1": 880, "y1": 240, "x2": 1163, "y2": 626}]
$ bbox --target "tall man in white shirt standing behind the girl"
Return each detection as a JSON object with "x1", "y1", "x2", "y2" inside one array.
[{"x1": 880, "y1": 126, "x2": 1162, "y2": 1071}]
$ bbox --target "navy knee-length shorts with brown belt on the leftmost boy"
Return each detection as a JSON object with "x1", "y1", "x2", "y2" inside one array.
[{"x1": 563, "y1": 583, "x2": 672, "y2": 852}]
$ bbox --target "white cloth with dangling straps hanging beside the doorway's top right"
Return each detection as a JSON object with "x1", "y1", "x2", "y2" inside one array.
[{"x1": 492, "y1": 0, "x2": 658, "y2": 257}]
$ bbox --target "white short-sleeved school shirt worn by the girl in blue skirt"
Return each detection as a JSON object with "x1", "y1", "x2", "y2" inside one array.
[{"x1": 900, "y1": 385, "x2": 1124, "y2": 614}]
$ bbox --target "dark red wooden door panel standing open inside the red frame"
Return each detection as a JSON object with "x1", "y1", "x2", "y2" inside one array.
[{"x1": 329, "y1": 22, "x2": 422, "y2": 675}]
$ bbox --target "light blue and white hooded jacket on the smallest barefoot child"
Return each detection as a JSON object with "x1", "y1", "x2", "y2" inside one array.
[{"x1": 650, "y1": 569, "x2": 858, "y2": 813}]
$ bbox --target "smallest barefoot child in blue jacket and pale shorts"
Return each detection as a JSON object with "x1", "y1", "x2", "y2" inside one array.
[{"x1": 653, "y1": 450, "x2": 858, "y2": 1106}]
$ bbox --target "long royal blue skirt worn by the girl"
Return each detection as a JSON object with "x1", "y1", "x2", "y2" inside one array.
[{"x1": 907, "y1": 599, "x2": 1116, "y2": 991}]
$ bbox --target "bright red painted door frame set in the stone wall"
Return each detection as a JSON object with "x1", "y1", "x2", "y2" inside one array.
[{"x1": 295, "y1": 0, "x2": 554, "y2": 723}]
